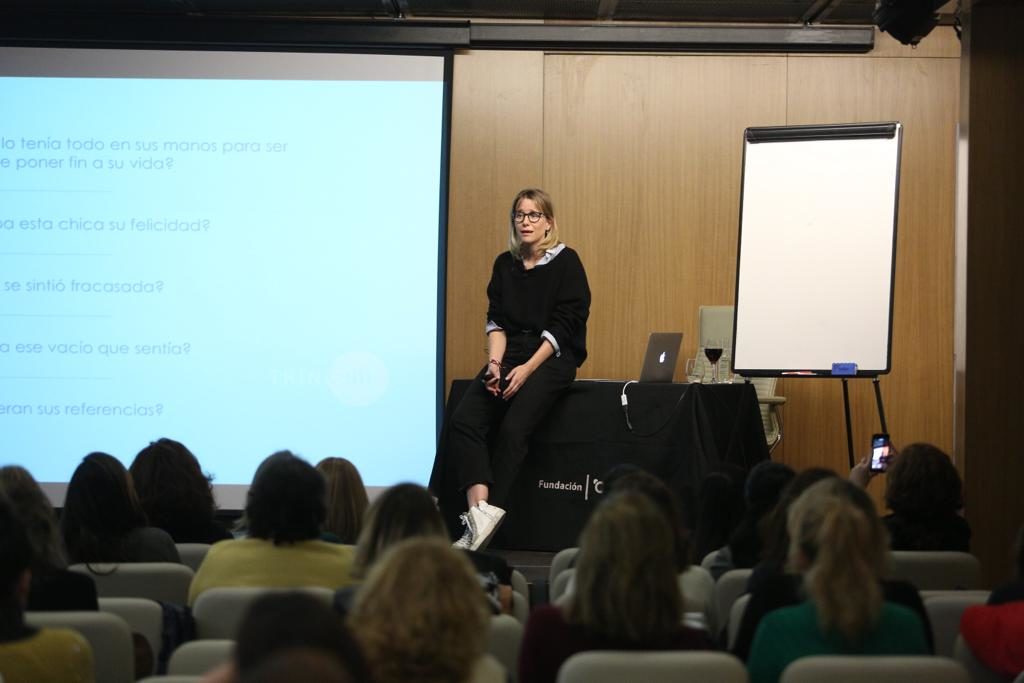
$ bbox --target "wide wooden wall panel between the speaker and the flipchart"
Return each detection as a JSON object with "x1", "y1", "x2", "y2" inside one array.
[{"x1": 544, "y1": 54, "x2": 785, "y2": 379}]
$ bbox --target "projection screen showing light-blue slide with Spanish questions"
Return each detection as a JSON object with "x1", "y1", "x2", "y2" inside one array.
[{"x1": 0, "y1": 45, "x2": 444, "y2": 499}]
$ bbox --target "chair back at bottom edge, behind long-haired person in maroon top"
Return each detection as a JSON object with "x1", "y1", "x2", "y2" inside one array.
[{"x1": 558, "y1": 650, "x2": 749, "y2": 683}]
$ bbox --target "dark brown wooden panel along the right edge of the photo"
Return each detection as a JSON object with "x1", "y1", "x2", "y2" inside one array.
[{"x1": 963, "y1": 0, "x2": 1024, "y2": 586}]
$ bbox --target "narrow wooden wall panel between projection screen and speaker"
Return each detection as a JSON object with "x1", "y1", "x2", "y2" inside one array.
[{"x1": 444, "y1": 52, "x2": 544, "y2": 391}]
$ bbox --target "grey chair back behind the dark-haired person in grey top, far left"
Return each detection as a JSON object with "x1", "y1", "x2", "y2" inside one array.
[{"x1": 68, "y1": 562, "x2": 196, "y2": 605}]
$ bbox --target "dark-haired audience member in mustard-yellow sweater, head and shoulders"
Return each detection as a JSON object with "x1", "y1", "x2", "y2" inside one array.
[{"x1": 188, "y1": 451, "x2": 353, "y2": 604}]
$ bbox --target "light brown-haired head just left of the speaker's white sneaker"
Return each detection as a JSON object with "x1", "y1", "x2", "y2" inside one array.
[{"x1": 352, "y1": 483, "x2": 447, "y2": 577}]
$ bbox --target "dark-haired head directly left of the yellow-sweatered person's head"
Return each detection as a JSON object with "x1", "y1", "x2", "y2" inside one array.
[{"x1": 129, "y1": 438, "x2": 216, "y2": 540}]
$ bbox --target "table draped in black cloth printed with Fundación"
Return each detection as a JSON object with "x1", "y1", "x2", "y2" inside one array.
[{"x1": 430, "y1": 380, "x2": 768, "y2": 551}]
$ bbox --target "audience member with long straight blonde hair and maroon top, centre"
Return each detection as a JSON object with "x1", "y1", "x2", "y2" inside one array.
[{"x1": 519, "y1": 490, "x2": 712, "y2": 683}]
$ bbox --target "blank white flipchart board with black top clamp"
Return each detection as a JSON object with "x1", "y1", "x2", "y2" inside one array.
[{"x1": 732, "y1": 123, "x2": 902, "y2": 376}]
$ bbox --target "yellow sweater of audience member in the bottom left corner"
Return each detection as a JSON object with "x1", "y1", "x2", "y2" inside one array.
[{"x1": 0, "y1": 629, "x2": 93, "y2": 683}]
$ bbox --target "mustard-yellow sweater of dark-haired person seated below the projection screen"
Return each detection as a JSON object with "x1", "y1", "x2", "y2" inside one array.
[{"x1": 188, "y1": 539, "x2": 354, "y2": 605}]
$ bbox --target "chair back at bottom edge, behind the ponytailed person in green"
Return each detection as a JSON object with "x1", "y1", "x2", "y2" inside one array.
[{"x1": 780, "y1": 655, "x2": 971, "y2": 683}]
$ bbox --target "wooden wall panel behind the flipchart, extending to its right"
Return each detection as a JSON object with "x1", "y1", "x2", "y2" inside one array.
[{"x1": 783, "y1": 56, "x2": 959, "y2": 498}]
